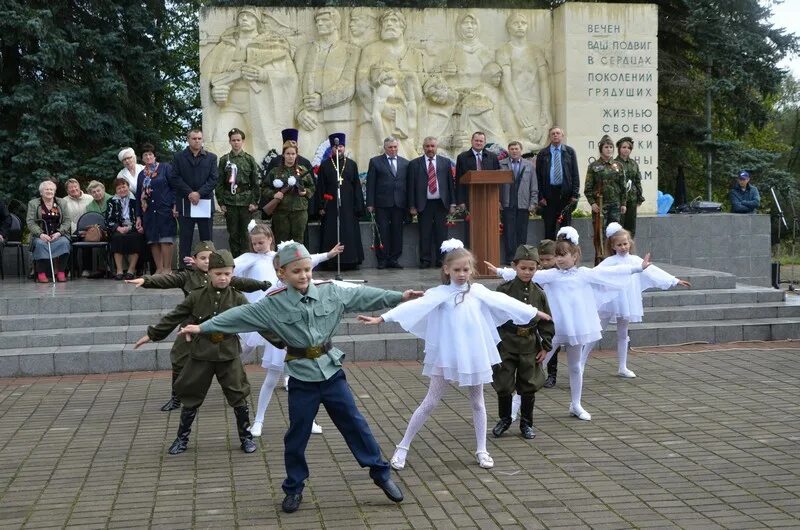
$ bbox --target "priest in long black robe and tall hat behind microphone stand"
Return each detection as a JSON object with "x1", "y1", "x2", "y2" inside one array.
[{"x1": 316, "y1": 133, "x2": 365, "y2": 270}]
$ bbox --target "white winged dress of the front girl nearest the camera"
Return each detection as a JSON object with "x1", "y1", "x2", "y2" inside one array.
[{"x1": 383, "y1": 284, "x2": 536, "y2": 386}]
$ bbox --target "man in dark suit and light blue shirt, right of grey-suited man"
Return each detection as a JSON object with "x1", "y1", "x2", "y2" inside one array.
[{"x1": 536, "y1": 127, "x2": 581, "y2": 240}]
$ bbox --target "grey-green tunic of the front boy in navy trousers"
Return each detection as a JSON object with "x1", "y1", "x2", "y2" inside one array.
[{"x1": 200, "y1": 283, "x2": 403, "y2": 382}]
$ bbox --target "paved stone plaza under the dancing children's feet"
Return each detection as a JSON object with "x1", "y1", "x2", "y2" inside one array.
[{"x1": 0, "y1": 342, "x2": 800, "y2": 529}]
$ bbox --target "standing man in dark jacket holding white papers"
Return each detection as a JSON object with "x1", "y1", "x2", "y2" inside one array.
[{"x1": 169, "y1": 129, "x2": 219, "y2": 266}]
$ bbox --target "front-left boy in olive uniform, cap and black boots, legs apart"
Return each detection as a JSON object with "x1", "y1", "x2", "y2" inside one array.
[{"x1": 134, "y1": 250, "x2": 256, "y2": 455}]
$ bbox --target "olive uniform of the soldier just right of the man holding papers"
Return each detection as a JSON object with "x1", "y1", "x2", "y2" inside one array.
[{"x1": 216, "y1": 150, "x2": 258, "y2": 257}]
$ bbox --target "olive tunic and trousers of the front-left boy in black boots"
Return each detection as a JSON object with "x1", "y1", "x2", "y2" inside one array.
[{"x1": 147, "y1": 284, "x2": 250, "y2": 409}]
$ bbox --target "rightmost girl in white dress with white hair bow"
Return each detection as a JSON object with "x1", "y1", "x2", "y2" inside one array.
[{"x1": 597, "y1": 223, "x2": 691, "y2": 378}]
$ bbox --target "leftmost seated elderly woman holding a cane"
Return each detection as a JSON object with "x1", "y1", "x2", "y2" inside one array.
[{"x1": 25, "y1": 180, "x2": 70, "y2": 283}]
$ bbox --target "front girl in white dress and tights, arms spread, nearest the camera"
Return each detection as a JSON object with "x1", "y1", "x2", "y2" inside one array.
[{"x1": 358, "y1": 239, "x2": 550, "y2": 470}]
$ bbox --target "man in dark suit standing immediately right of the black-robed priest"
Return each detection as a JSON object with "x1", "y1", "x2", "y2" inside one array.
[{"x1": 367, "y1": 136, "x2": 408, "y2": 269}]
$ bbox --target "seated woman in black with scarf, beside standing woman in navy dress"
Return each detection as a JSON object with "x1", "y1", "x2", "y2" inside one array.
[{"x1": 106, "y1": 177, "x2": 144, "y2": 280}]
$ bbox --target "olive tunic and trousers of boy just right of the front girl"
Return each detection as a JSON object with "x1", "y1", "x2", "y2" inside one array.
[{"x1": 492, "y1": 278, "x2": 555, "y2": 396}]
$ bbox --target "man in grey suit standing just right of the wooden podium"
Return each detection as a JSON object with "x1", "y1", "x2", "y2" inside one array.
[{"x1": 500, "y1": 141, "x2": 539, "y2": 263}]
